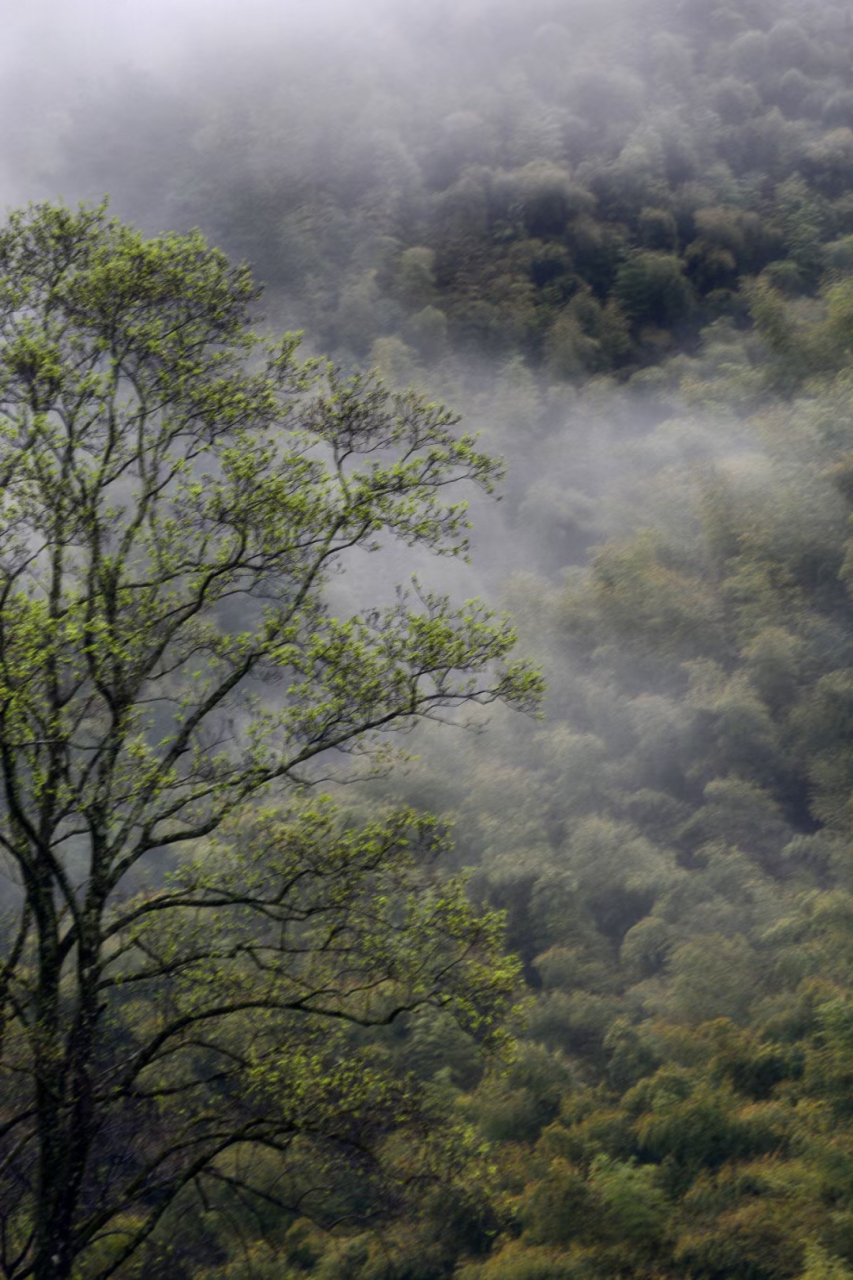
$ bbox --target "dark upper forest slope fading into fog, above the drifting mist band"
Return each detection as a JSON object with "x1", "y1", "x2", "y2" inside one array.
[{"x1": 36, "y1": 0, "x2": 853, "y2": 379}]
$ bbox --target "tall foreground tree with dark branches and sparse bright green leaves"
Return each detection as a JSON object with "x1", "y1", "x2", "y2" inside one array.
[{"x1": 0, "y1": 205, "x2": 539, "y2": 1280}]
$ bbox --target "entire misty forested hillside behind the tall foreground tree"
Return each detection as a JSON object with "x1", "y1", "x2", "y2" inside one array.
[{"x1": 6, "y1": 0, "x2": 853, "y2": 1280}]
